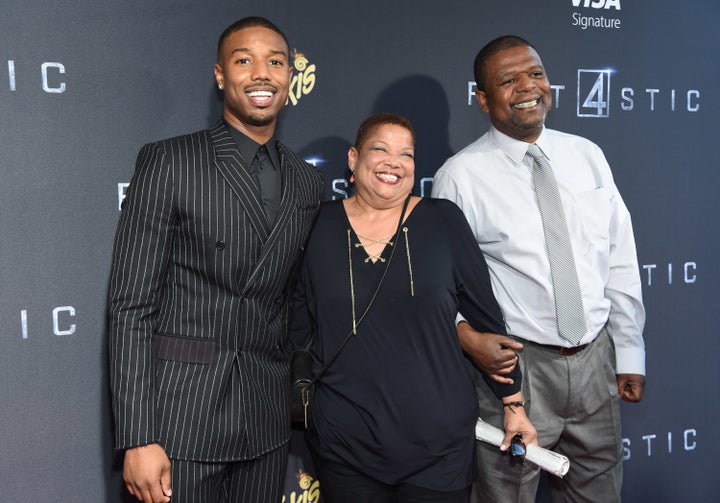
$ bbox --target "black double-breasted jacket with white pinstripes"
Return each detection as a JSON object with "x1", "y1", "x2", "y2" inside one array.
[{"x1": 108, "y1": 121, "x2": 322, "y2": 462}]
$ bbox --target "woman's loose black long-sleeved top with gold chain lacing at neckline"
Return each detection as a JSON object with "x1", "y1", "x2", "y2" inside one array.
[{"x1": 291, "y1": 199, "x2": 520, "y2": 491}]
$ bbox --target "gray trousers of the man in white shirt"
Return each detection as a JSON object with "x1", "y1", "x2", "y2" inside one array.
[{"x1": 471, "y1": 330, "x2": 622, "y2": 503}]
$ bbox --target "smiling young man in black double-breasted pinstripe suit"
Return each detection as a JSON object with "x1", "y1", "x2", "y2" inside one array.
[{"x1": 109, "y1": 17, "x2": 322, "y2": 503}]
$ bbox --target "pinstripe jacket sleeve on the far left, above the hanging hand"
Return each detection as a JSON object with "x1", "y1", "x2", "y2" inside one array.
[{"x1": 108, "y1": 144, "x2": 174, "y2": 450}]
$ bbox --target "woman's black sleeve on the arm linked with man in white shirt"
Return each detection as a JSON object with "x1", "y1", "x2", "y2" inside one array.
[{"x1": 448, "y1": 203, "x2": 522, "y2": 398}]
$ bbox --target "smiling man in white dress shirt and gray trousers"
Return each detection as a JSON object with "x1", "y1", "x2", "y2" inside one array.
[{"x1": 432, "y1": 36, "x2": 645, "y2": 502}]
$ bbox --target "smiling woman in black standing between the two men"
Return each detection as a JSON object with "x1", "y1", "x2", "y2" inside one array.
[{"x1": 291, "y1": 114, "x2": 536, "y2": 503}]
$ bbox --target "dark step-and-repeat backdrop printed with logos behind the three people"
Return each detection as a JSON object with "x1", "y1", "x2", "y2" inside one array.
[{"x1": 0, "y1": 0, "x2": 720, "y2": 503}]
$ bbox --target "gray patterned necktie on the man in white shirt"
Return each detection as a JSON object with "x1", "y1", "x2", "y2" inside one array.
[{"x1": 527, "y1": 143, "x2": 587, "y2": 344}]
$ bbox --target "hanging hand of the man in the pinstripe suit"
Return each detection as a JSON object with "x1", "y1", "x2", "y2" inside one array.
[{"x1": 123, "y1": 444, "x2": 172, "y2": 503}]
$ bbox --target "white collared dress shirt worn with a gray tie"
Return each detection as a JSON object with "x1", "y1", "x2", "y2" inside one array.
[{"x1": 432, "y1": 128, "x2": 645, "y2": 374}]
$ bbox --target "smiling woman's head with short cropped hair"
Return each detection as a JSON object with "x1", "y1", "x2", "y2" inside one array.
[{"x1": 348, "y1": 124, "x2": 415, "y2": 207}]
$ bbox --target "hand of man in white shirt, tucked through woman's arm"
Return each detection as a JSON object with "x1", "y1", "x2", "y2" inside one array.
[{"x1": 457, "y1": 321, "x2": 523, "y2": 384}]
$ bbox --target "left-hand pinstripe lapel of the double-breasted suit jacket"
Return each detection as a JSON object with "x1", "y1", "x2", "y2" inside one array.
[{"x1": 210, "y1": 121, "x2": 270, "y2": 241}]
